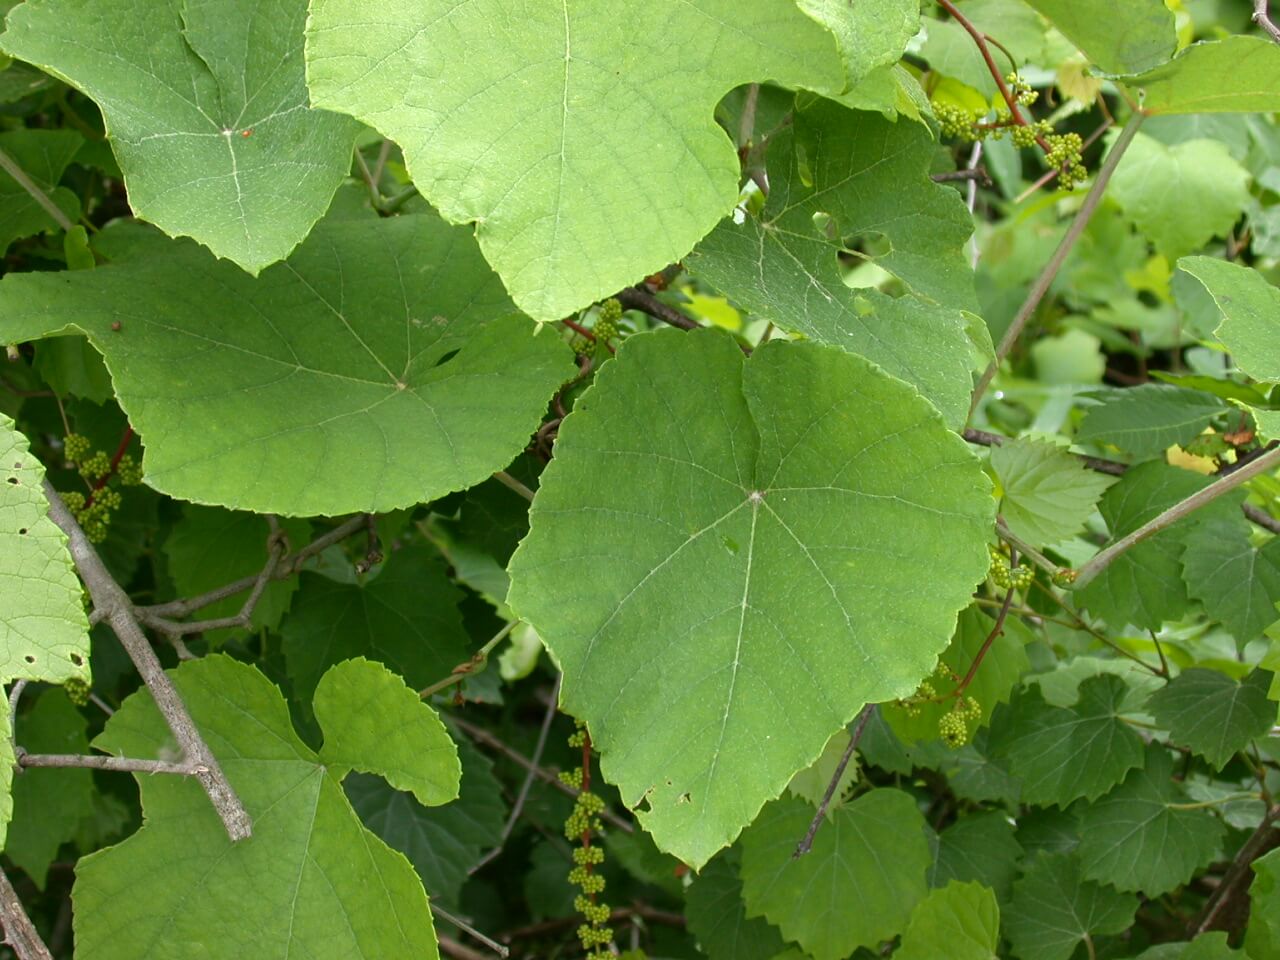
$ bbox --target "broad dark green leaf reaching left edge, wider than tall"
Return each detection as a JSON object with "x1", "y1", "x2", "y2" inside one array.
[{"x1": 0, "y1": 216, "x2": 573, "y2": 516}]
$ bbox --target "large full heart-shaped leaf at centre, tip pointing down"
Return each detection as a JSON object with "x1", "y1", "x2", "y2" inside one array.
[{"x1": 508, "y1": 330, "x2": 992, "y2": 865}]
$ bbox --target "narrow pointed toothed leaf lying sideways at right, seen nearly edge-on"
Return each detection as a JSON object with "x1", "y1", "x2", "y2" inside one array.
[{"x1": 1075, "y1": 383, "x2": 1230, "y2": 458}]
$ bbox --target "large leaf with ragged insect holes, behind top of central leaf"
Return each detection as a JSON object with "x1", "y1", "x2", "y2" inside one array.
[{"x1": 687, "y1": 100, "x2": 974, "y2": 426}]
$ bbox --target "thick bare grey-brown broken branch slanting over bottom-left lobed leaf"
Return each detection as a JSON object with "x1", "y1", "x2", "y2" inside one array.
[{"x1": 45, "y1": 477, "x2": 253, "y2": 841}]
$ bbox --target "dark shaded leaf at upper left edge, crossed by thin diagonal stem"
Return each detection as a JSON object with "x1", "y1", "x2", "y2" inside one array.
[{"x1": 0, "y1": 129, "x2": 84, "y2": 253}]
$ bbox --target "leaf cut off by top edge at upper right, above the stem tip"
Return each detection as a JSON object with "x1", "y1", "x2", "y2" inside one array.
[{"x1": 1027, "y1": 0, "x2": 1178, "y2": 73}]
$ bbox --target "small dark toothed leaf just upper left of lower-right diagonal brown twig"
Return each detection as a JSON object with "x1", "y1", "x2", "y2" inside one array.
[{"x1": 1079, "y1": 745, "x2": 1226, "y2": 897}]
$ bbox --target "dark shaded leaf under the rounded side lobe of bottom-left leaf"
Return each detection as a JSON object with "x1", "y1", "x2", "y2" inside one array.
[{"x1": 342, "y1": 739, "x2": 507, "y2": 906}]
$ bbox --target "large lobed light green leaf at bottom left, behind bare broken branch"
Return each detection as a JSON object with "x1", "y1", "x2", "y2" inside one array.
[{"x1": 72, "y1": 655, "x2": 460, "y2": 960}]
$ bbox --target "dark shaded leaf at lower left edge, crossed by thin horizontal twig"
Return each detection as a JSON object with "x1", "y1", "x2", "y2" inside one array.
[{"x1": 4, "y1": 690, "x2": 93, "y2": 890}]
